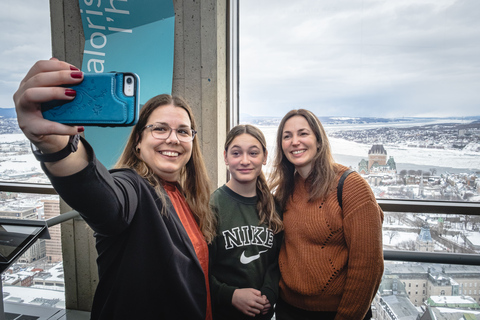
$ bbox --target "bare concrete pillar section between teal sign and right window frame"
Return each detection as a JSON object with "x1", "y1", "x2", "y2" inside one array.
[{"x1": 172, "y1": 0, "x2": 228, "y2": 190}]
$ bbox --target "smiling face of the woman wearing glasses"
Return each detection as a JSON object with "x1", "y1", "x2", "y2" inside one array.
[{"x1": 137, "y1": 104, "x2": 193, "y2": 181}]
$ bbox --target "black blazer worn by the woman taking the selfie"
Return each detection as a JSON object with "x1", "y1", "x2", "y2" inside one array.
[{"x1": 43, "y1": 140, "x2": 207, "y2": 320}]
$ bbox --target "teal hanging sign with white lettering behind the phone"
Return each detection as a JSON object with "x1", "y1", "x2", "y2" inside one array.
[{"x1": 79, "y1": 0, "x2": 175, "y2": 168}]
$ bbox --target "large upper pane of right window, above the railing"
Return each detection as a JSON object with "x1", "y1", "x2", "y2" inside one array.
[{"x1": 239, "y1": 0, "x2": 480, "y2": 202}]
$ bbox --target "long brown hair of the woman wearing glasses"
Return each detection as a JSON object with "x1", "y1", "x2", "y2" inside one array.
[{"x1": 115, "y1": 94, "x2": 215, "y2": 243}]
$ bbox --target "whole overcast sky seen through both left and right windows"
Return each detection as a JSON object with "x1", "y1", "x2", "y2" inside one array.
[{"x1": 0, "y1": 0, "x2": 480, "y2": 117}]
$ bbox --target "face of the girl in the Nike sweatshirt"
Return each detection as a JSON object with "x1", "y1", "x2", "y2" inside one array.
[{"x1": 223, "y1": 133, "x2": 267, "y2": 191}]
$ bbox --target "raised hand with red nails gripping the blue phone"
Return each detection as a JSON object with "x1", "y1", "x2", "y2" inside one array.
[{"x1": 13, "y1": 58, "x2": 83, "y2": 153}]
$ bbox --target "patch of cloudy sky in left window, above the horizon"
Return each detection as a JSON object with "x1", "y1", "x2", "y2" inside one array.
[{"x1": 0, "y1": 0, "x2": 52, "y2": 108}]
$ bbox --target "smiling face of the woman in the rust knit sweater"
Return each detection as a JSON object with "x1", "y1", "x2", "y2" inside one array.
[{"x1": 282, "y1": 116, "x2": 319, "y2": 178}]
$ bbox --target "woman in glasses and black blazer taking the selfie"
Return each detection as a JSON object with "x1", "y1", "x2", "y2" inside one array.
[{"x1": 14, "y1": 59, "x2": 215, "y2": 320}]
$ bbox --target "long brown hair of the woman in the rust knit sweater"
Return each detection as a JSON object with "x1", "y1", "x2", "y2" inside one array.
[{"x1": 269, "y1": 109, "x2": 336, "y2": 210}]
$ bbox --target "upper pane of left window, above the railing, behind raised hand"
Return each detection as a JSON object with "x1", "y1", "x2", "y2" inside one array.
[{"x1": 0, "y1": 0, "x2": 52, "y2": 183}]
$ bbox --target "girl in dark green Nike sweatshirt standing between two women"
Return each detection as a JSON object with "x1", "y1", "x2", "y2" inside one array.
[{"x1": 210, "y1": 125, "x2": 283, "y2": 320}]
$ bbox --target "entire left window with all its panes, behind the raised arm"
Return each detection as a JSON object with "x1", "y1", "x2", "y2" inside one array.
[{"x1": 0, "y1": 0, "x2": 65, "y2": 310}]
